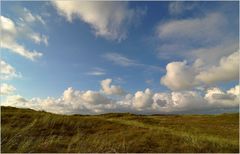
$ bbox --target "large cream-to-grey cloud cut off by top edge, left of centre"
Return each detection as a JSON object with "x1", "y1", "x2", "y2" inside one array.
[{"x1": 52, "y1": 1, "x2": 146, "y2": 41}]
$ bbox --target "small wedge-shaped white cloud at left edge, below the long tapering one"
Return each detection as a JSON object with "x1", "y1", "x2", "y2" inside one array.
[{"x1": 0, "y1": 59, "x2": 21, "y2": 80}]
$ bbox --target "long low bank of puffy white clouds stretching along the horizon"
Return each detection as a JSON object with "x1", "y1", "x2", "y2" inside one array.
[{"x1": 2, "y1": 80, "x2": 240, "y2": 114}]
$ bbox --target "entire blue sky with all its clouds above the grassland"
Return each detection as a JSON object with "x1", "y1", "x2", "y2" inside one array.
[{"x1": 0, "y1": 1, "x2": 240, "y2": 114}]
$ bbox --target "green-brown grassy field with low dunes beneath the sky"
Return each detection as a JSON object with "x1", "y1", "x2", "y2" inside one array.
[{"x1": 1, "y1": 107, "x2": 239, "y2": 153}]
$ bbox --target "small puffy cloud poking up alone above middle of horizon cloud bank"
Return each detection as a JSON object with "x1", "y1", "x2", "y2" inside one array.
[{"x1": 101, "y1": 79, "x2": 125, "y2": 95}]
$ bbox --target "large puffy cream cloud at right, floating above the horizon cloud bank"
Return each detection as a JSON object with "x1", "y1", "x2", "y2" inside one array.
[{"x1": 161, "y1": 52, "x2": 239, "y2": 90}]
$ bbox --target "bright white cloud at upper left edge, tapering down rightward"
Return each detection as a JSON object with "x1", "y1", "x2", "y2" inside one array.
[{"x1": 1, "y1": 16, "x2": 42, "y2": 60}]
